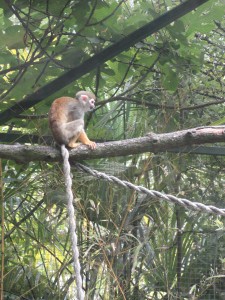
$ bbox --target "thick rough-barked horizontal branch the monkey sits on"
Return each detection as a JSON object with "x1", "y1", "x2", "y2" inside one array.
[{"x1": 0, "y1": 126, "x2": 225, "y2": 163}]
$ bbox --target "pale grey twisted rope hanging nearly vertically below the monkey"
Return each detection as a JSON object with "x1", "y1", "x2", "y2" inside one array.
[{"x1": 61, "y1": 145, "x2": 85, "y2": 300}]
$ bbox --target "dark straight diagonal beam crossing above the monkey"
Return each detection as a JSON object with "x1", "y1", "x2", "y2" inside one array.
[{"x1": 0, "y1": 0, "x2": 208, "y2": 125}]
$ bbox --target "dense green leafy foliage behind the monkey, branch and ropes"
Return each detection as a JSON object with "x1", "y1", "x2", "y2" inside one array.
[{"x1": 0, "y1": 0, "x2": 225, "y2": 299}]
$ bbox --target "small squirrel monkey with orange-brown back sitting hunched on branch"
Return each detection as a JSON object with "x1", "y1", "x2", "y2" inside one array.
[{"x1": 49, "y1": 91, "x2": 96, "y2": 149}]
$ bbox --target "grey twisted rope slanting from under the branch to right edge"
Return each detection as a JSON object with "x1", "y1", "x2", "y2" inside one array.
[{"x1": 76, "y1": 163, "x2": 225, "y2": 216}]
